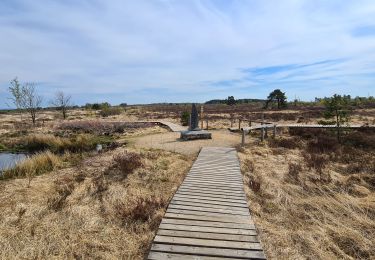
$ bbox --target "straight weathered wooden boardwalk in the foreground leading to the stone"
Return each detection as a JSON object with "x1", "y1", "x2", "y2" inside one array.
[{"x1": 148, "y1": 147, "x2": 265, "y2": 259}]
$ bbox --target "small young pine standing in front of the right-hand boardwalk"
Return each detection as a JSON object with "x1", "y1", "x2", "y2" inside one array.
[{"x1": 323, "y1": 94, "x2": 350, "y2": 143}]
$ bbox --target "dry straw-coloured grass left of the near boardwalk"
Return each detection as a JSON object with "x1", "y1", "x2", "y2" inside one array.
[{"x1": 0, "y1": 148, "x2": 192, "y2": 259}]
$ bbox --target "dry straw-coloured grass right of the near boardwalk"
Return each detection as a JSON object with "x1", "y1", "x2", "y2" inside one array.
[{"x1": 239, "y1": 137, "x2": 375, "y2": 259}]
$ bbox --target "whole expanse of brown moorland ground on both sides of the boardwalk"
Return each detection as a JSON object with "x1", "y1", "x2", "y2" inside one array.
[{"x1": 0, "y1": 105, "x2": 375, "y2": 259}]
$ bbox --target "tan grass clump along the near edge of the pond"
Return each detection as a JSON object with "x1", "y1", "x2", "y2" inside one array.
[{"x1": 2, "y1": 151, "x2": 62, "y2": 179}]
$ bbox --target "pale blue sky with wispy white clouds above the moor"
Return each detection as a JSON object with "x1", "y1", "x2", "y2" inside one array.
[{"x1": 0, "y1": 0, "x2": 375, "y2": 107}]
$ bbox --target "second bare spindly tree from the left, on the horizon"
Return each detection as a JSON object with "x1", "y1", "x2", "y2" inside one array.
[{"x1": 21, "y1": 83, "x2": 43, "y2": 125}]
